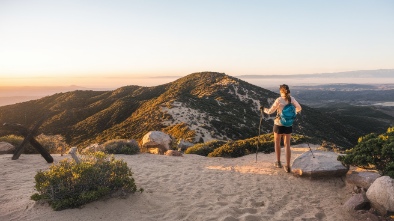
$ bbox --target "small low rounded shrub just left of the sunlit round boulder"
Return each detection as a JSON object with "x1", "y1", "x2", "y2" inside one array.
[{"x1": 102, "y1": 139, "x2": 140, "y2": 155}]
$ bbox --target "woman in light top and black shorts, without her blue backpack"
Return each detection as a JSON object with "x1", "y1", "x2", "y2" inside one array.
[{"x1": 264, "y1": 84, "x2": 302, "y2": 173}]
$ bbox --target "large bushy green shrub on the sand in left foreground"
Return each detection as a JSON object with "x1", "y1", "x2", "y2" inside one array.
[{"x1": 31, "y1": 152, "x2": 142, "y2": 210}]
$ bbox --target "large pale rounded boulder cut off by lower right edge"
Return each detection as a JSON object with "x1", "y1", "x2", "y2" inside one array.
[{"x1": 367, "y1": 176, "x2": 394, "y2": 215}]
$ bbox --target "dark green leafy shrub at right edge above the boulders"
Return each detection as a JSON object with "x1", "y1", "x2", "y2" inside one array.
[{"x1": 338, "y1": 128, "x2": 394, "y2": 178}]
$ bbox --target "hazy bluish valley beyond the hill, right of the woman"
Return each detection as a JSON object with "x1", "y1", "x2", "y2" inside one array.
[{"x1": 292, "y1": 84, "x2": 394, "y2": 137}]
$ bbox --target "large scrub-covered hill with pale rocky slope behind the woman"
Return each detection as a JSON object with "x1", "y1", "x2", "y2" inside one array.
[{"x1": 0, "y1": 72, "x2": 366, "y2": 147}]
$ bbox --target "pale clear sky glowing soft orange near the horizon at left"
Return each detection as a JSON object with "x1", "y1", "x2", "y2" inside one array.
[{"x1": 0, "y1": 0, "x2": 394, "y2": 87}]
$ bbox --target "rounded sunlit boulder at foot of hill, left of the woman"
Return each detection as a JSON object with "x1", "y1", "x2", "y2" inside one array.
[{"x1": 142, "y1": 131, "x2": 172, "y2": 154}]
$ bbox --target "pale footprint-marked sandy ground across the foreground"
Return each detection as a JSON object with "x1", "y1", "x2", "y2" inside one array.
[{"x1": 0, "y1": 145, "x2": 358, "y2": 221}]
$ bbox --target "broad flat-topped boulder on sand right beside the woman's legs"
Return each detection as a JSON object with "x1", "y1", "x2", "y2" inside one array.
[{"x1": 292, "y1": 151, "x2": 349, "y2": 177}]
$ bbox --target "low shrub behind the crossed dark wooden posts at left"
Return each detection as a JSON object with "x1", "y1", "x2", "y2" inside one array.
[{"x1": 0, "y1": 134, "x2": 69, "y2": 154}]
